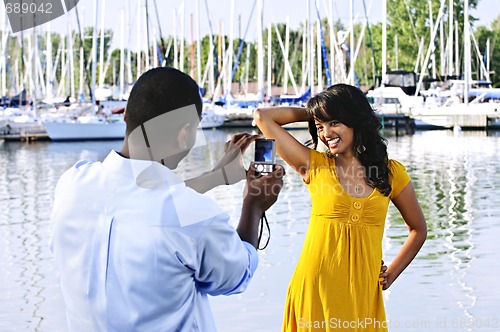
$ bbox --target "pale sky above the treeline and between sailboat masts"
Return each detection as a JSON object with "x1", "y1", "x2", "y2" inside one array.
[{"x1": 2, "y1": 0, "x2": 500, "y2": 49}]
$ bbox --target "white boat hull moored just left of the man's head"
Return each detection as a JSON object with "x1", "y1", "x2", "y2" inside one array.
[{"x1": 43, "y1": 115, "x2": 126, "y2": 141}]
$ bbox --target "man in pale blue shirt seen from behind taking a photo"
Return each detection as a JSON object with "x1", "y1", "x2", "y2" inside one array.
[{"x1": 51, "y1": 68, "x2": 284, "y2": 332}]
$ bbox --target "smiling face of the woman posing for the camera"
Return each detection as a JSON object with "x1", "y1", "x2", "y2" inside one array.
[{"x1": 314, "y1": 119, "x2": 354, "y2": 154}]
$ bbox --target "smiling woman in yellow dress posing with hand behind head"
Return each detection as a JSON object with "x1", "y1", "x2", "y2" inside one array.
[{"x1": 254, "y1": 84, "x2": 427, "y2": 331}]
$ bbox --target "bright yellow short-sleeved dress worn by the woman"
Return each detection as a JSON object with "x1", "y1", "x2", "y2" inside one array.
[{"x1": 283, "y1": 150, "x2": 410, "y2": 332}]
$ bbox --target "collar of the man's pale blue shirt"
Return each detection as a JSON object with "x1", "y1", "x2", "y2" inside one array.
[{"x1": 102, "y1": 150, "x2": 185, "y2": 189}]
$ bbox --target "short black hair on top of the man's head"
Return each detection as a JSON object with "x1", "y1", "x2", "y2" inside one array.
[{"x1": 126, "y1": 67, "x2": 203, "y2": 135}]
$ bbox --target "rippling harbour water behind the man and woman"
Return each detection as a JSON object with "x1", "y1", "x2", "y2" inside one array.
[{"x1": 0, "y1": 130, "x2": 500, "y2": 332}]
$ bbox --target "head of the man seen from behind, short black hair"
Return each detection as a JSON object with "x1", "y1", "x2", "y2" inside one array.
[{"x1": 125, "y1": 67, "x2": 202, "y2": 168}]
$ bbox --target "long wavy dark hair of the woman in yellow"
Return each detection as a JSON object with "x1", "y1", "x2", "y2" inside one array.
[{"x1": 307, "y1": 84, "x2": 391, "y2": 196}]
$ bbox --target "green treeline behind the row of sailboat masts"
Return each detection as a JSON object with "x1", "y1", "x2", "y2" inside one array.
[{"x1": 3, "y1": 0, "x2": 500, "y2": 100}]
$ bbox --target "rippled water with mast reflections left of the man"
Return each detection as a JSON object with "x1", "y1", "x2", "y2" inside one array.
[{"x1": 0, "y1": 142, "x2": 121, "y2": 331}]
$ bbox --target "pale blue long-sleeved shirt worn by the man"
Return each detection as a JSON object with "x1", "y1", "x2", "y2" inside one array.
[{"x1": 51, "y1": 151, "x2": 258, "y2": 332}]
